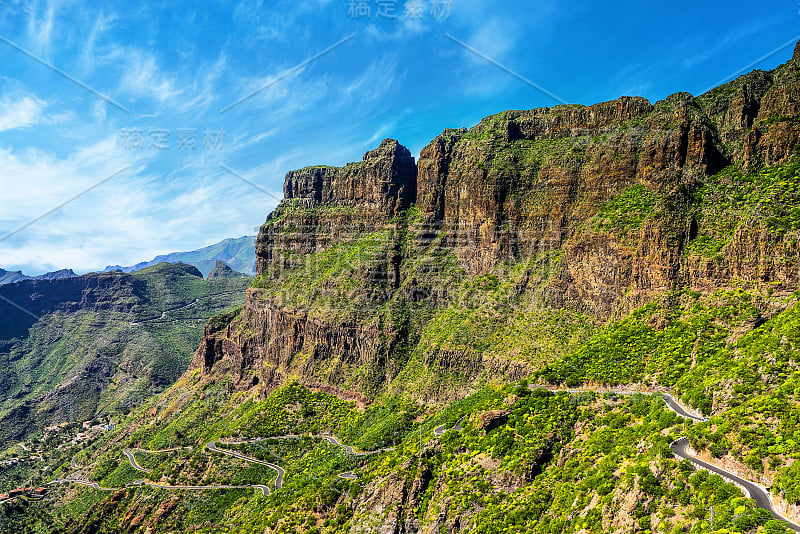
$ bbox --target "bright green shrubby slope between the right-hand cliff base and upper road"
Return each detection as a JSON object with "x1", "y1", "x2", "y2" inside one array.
[{"x1": 538, "y1": 290, "x2": 800, "y2": 413}]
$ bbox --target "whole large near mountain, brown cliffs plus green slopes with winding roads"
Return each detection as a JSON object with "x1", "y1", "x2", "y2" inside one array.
[{"x1": 0, "y1": 40, "x2": 800, "y2": 534}]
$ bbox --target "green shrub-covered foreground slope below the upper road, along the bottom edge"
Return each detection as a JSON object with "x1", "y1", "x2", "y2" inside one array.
[{"x1": 0, "y1": 368, "x2": 794, "y2": 533}]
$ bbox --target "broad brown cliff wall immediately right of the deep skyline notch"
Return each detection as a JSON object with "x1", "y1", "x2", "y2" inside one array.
[{"x1": 419, "y1": 93, "x2": 725, "y2": 317}]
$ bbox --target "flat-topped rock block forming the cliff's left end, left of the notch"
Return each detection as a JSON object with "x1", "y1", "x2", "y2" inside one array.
[{"x1": 193, "y1": 139, "x2": 416, "y2": 397}]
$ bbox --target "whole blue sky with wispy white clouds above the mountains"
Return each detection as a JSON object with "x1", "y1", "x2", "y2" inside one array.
[{"x1": 0, "y1": 0, "x2": 800, "y2": 274}]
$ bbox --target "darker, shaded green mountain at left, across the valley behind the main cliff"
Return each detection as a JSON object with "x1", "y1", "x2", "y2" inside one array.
[{"x1": 0, "y1": 263, "x2": 249, "y2": 448}]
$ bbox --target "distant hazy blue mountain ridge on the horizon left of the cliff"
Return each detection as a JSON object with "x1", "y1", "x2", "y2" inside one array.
[{"x1": 103, "y1": 236, "x2": 255, "y2": 276}]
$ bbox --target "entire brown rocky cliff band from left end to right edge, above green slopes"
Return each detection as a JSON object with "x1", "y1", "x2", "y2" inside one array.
[{"x1": 194, "y1": 46, "x2": 800, "y2": 395}]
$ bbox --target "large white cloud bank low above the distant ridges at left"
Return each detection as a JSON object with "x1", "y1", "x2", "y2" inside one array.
[{"x1": 0, "y1": 138, "x2": 282, "y2": 274}]
